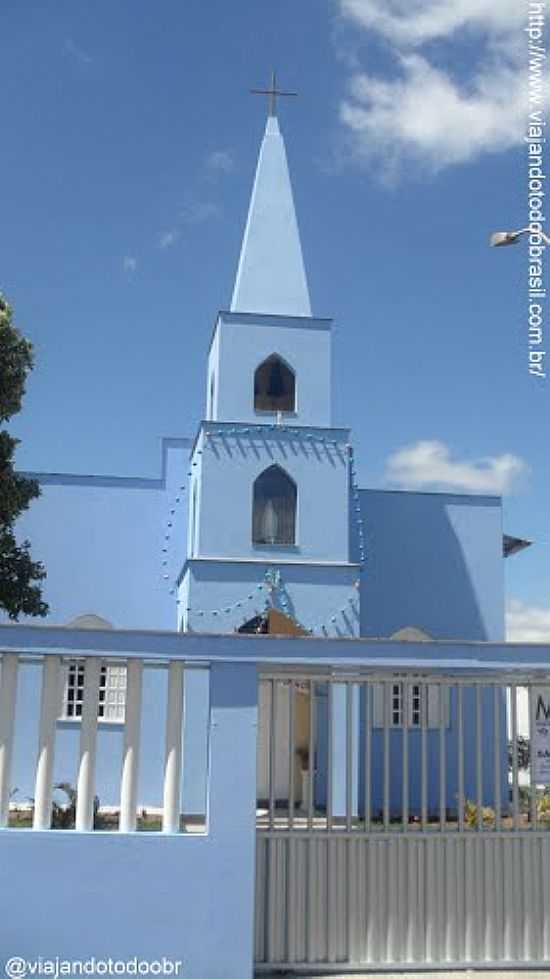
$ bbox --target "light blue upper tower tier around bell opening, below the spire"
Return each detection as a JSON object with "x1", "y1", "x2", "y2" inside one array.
[{"x1": 208, "y1": 312, "x2": 332, "y2": 427}]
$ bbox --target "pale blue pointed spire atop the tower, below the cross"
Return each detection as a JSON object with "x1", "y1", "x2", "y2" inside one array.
[{"x1": 231, "y1": 114, "x2": 311, "y2": 316}]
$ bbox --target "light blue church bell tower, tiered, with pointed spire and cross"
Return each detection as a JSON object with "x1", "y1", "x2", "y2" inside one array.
[{"x1": 178, "y1": 90, "x2": 359, "y2": 636}]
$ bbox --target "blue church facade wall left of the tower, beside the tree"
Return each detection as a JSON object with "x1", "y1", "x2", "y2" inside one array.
[{"x1": 0, "y1": 439, "x2": 189, "y2": 629}]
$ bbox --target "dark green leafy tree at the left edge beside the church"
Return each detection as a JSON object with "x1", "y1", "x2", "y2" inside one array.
[{"x1": 0, "y1": 295, "x2": 48, "y2": 619}]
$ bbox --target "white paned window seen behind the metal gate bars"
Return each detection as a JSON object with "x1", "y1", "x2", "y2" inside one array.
[{"x1": 372, "y1": 681, "x2": 449, "y2": 728}]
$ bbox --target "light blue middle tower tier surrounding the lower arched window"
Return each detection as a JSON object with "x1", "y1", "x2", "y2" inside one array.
[{"x1": 192, "y1": 423, "x2": 349, "y2": 562}]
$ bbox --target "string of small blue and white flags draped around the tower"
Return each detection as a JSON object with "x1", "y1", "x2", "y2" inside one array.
[{"x1": 161, "y1": 424, "x2": 366, "y2": 635}]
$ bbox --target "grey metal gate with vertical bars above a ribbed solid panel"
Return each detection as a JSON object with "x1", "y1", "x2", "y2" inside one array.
[{"x1": 255, "y1": 670, "x2": 550, "y2": 973}]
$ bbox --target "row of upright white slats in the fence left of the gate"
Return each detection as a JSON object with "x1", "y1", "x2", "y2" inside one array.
[{"x1": 0, "y1": 653, "x2": 207, "y2": 833}]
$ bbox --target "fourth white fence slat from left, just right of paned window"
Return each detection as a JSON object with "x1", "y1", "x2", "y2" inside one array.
[{"x1": 119, "y1": 659, "x2": 143, "y2": 833}]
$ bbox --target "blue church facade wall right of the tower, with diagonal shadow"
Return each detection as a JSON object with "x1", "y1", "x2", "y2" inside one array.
[{"x1": 358, "y1": 490, "x2": 504, "y2": 640}]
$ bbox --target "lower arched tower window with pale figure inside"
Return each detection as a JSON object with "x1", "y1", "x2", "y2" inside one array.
[{"x1": 252, "y1": 466, "x2": 297, "y2": 544}]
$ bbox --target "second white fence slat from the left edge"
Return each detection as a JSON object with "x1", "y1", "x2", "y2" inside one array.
[{"x1": 33, "y1": 655, "x2": 62, "y2": 830}]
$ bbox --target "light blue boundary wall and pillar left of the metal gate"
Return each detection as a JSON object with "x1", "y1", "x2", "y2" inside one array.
[{"x1": 0, "y1": 664, "x2": 257, "y2": 979}]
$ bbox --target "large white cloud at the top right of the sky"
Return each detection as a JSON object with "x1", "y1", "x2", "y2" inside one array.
[{"x1": 340, "y1": 0, "x2": 527, "y2": 178}]
